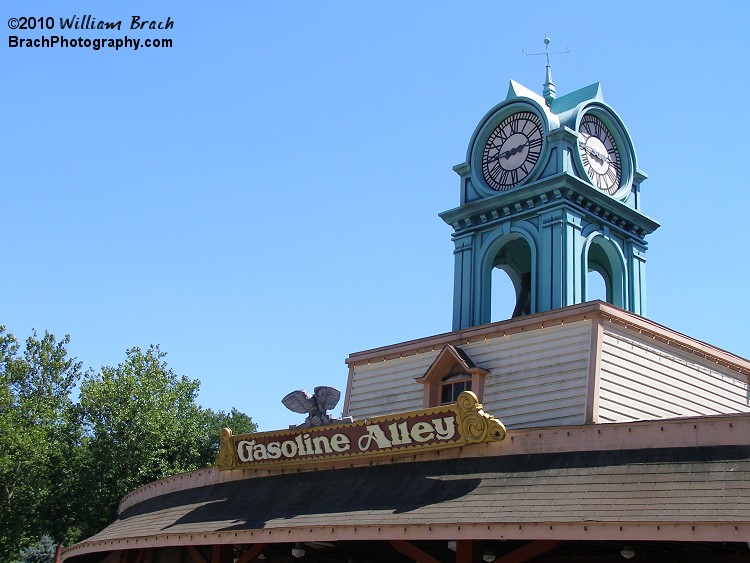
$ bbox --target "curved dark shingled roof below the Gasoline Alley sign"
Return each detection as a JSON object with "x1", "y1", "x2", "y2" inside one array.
[{"x1": 87, "y1": 446, "x2": 750, "y2": 541}]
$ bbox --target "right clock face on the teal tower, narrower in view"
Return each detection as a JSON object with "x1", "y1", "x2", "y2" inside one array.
[{"x1": 578, "y1": 113, "x2": 622, "y2": 195}]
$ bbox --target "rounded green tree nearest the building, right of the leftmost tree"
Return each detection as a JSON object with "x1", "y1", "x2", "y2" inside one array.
[{"x1": 80, "y1": 346, "x2": 254, "y2": 528}]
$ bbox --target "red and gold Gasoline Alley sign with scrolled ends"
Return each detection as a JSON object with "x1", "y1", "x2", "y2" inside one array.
[{"x1": 216, "y1": 391, "x2": 505, "y2": 469}]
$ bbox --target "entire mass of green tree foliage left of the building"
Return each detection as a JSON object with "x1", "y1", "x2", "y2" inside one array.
[{"x1": 0, "y1": 326, "x2": 256, "y2": 561}]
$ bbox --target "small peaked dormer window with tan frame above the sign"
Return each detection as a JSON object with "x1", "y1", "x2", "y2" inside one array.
[{"x1": 417, "y1": 344, "x2": 489, "y2": 408}]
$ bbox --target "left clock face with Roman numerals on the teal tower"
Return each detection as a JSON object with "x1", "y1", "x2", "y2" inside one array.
[{"x1": 482, "y1": 111, "x2": 544, "y2": 191}]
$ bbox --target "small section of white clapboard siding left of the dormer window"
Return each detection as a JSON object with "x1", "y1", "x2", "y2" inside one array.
[{"x1": 348, "y1": 351, "x2": 439, "y2": 420}]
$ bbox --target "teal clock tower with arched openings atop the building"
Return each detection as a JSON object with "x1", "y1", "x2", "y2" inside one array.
[{"x1": 440, "y1": 77, "x2": 659, "y2": 330}]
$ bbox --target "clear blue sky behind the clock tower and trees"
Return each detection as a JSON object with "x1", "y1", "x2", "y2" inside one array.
[{"x1": 5, "y1": 0, "x2": 750, "y2": 430}]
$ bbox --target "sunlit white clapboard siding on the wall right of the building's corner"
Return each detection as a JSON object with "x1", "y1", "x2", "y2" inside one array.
[{"x1": 599, "y1": 327, "x2": 750, "y2": 422}]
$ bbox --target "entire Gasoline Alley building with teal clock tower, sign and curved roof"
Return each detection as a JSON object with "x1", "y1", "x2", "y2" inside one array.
[{"x1": 61, "y1": 71, "x2": 750, "y2": 563}]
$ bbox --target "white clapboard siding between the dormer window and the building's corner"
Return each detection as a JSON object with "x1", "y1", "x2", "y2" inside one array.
[{"x1": 462, "y1": 321, "x2": 591, "y2": 428}]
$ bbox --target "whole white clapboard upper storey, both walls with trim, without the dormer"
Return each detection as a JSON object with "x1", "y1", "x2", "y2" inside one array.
[{"x1": 347, "y1": 303, "x2": 750, "y2": 428}]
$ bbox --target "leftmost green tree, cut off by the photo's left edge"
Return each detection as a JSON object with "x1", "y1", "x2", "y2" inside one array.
[{"x1": 0, "y1": 327, "x2": 81, "y2": 561}]
